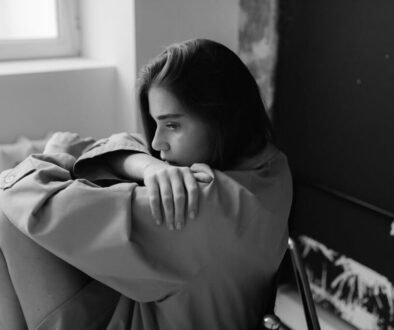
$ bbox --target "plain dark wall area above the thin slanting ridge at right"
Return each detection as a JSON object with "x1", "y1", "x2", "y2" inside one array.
[{"x1": 274, "y1": 0, "x2": 394, "y2": 212}]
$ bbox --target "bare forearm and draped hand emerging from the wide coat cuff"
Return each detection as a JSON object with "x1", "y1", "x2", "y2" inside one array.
[{"x1": 106, "y1": 152, "x2": 212, "y2": 230}]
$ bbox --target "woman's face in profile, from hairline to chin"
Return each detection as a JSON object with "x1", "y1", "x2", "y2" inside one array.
[{"x1": 148, "y1": 86, "x2": 213, "y2": 166}]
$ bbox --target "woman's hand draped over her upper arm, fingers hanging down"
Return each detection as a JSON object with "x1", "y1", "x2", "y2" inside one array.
[{"x1": 143, "y1": 162, "x2": 212, "y2": 230}]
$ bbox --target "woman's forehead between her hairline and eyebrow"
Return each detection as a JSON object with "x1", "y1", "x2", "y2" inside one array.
[{"x1": 148, "y1": 87, "x2": 186, "y2": 118}]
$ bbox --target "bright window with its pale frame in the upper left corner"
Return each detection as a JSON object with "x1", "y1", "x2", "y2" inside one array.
[{"x1": 0, "y1": 0, "x2": 79, "y2": 60}]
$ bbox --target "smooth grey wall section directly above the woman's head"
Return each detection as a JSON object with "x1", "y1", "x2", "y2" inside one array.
[{"x1": 135, "y1": 0, "x2": 239, "y2": 69}]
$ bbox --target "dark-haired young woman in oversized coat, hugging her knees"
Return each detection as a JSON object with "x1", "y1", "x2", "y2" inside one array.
[{"x1": 0, "y1": 39, "x2": 292, "y2": 330}]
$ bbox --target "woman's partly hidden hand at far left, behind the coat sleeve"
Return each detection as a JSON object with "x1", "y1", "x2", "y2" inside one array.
[{"x1": 44, "y1": 132, "x2": 94, "y2": 158}]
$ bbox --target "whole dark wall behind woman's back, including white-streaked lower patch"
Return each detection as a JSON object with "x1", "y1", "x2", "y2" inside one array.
[{"x1": 273, "y1": 0, "x2": 394, "y2": 324}]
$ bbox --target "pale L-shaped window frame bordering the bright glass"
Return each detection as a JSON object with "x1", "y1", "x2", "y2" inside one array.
[{"x1": 0, "y1": 0, "x2": 80, "y2": 61}]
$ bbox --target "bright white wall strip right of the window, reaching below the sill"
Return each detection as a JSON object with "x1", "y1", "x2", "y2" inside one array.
[{"x1": 80, "y1": 0, "x2": 138, "y2": 131}]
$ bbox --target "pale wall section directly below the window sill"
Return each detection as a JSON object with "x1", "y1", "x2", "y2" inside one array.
[{"x1": 0, "y1": 64, "x2": 114, "y2": 143}]
